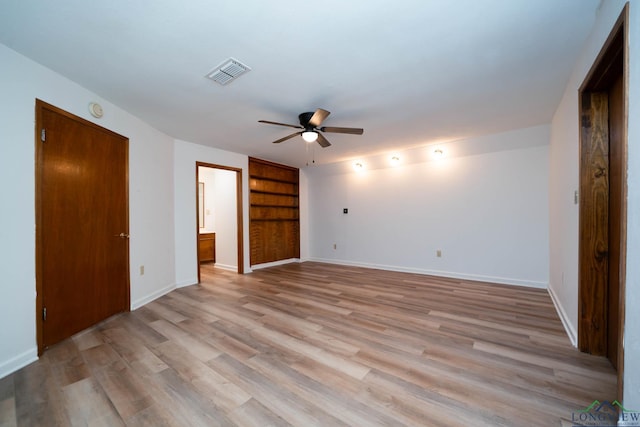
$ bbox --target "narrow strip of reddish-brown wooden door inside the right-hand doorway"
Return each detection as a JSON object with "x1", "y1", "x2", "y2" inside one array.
[{"x1": 607, "y1": 74, "x2": 625, "y2": 368}]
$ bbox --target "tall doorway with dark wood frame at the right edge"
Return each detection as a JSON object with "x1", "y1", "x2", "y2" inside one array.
[{"x1": 578, "y1": 5, "x2": 629, "y2": 399}]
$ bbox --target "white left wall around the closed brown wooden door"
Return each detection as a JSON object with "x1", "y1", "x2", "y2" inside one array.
[{"x1": 0, "y1": 45, "x2": 175, "y2": 377}]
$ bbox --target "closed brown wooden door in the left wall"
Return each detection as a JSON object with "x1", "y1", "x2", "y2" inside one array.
[{"x1": 36, "y1": 102, "x2": 129, "y2": 351}]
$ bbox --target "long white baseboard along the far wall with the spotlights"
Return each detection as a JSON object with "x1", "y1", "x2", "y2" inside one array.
[{"x1": 309, "y1": 258, "x2": 547, "y2": 289}]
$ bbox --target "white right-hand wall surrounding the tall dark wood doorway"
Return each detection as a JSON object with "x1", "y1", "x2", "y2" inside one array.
[{"x1": 549, "y1": 0, "x2": 640, "y2": 409}]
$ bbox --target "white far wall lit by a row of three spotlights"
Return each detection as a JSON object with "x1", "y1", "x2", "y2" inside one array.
[{"x1": 305, "y1": 126, "x2": 549, "y2": 288}]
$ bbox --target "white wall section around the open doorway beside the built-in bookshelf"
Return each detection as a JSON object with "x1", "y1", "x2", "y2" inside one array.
[{"x1": 174, "y1": 140, "x2": 251, "y2": 286}]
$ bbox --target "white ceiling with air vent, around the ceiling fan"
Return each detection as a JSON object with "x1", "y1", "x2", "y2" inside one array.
[{"x1": 0, "y1": 0, "x2": 599, "y2": 166}]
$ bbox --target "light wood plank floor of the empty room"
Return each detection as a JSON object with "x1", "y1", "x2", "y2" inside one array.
[{"x1": 0, "y1": 263, "x2": 615, "y2": 427}]
